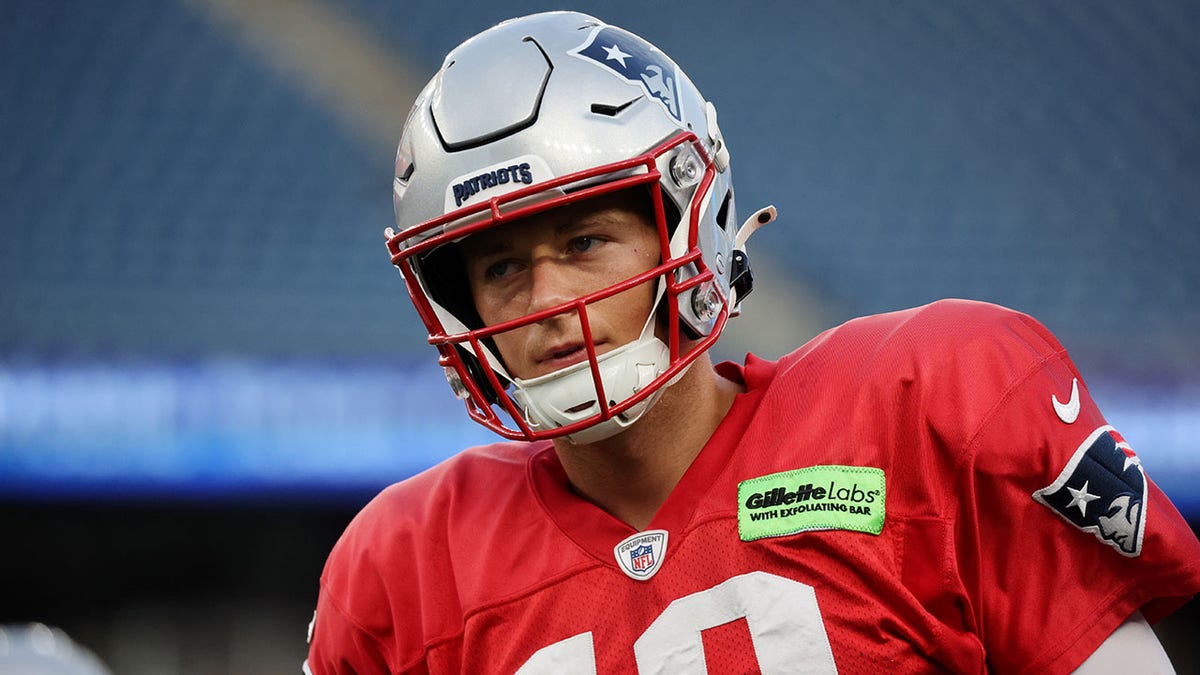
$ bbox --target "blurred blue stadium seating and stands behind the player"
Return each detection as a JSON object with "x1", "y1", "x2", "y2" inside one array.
[{"x1": 0, "y1": 0, "x2": 1200, "y2": 675}]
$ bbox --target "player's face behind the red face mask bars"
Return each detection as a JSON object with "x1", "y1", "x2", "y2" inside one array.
[{"x1": 461, "y1": 191, "x2": 661, "y2": 380}]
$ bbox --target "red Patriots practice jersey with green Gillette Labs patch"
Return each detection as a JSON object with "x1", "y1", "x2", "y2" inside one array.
[{"x1": 308, "y1": 300, "x2": 1200, "y2": 675}]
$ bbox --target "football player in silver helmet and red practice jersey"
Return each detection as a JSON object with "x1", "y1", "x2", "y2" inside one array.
[{"x1": 307, "y1": 12, "x2": 1200, "y2": 675}]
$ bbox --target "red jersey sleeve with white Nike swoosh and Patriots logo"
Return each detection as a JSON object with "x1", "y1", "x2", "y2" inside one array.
[{"x1": 954, "y1": 315, "x2": 1200, "y2": 673}]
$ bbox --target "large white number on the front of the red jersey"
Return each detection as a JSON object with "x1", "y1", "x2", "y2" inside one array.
[{"x1": 517, "y1": 572, "x2": 838, "y2": 675}]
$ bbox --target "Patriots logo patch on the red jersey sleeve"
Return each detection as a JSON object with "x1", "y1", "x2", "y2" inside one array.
[{"x1": 1033, "y1": 426, "x2": 1146, "y2": 557}]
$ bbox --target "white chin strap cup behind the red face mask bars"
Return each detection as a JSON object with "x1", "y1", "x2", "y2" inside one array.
[{"x1": 512, "y1": 322, "x2": 678, "y2": 444}]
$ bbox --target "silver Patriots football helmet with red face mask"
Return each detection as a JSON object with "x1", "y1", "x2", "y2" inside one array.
[{"x1": 386, "y1": 12, "x2": 774, "y2": 443}]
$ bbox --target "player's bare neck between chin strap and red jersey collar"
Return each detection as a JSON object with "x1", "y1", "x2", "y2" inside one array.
[{"x1": 554, "y1": 354, "x2": 742, "y2": 530}]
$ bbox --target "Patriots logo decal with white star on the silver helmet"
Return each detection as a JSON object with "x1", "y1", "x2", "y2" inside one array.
[{"x1": 570, "y1": 25, "x2": 683, "y2": 120}]
